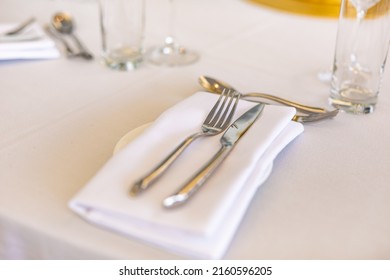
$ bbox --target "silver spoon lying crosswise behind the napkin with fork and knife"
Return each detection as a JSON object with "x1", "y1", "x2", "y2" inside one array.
[{"x1": 199, "y1": 76, "x2": 327, "y2": 113}]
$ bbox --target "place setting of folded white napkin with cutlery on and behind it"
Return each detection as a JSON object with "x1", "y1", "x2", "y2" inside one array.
[{"x1": 69, "y1": 76, "x2": 338, "y2": 259}]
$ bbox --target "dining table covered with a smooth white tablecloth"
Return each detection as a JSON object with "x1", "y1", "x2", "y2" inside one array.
[{"x1": 0, "y1": 0, "x2": 390, "y2": 260}]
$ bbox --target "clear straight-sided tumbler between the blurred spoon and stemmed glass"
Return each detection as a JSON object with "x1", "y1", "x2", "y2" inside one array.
[{"x1": 99, "y1": 0, "x2": 145, "y2": 71}]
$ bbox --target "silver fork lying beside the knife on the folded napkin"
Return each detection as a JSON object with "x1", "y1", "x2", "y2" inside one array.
[{"x1": 130, "y1": 89, "x2": 240, "y2": 196}]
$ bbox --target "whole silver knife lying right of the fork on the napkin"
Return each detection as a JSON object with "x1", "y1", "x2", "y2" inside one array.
[{"x1": 163, "y1": 103, "x2": 265, "y2": 208}]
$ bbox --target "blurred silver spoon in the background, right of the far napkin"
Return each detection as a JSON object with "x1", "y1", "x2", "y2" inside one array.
[{"x1": 51, "y1": 12, "x2": 93, "y2": 60}]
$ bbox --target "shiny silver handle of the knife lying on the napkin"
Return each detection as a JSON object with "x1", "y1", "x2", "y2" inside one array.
[{"x1": 163, "y1": 146, "x2": 233, "y2": 208}]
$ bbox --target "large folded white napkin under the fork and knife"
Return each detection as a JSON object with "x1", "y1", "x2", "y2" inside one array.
[{"x1": 69, "y1": 92, "x2": 303, "y2": 259}]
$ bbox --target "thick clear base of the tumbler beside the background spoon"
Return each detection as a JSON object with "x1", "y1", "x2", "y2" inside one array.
[{"x1": 102, "y1": 48, "x2": 143, "y2": 71}]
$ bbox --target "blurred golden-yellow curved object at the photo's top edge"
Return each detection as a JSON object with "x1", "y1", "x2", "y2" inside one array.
[{"x1": 249, "y1": 0, "x2": 341, "y2": 18}]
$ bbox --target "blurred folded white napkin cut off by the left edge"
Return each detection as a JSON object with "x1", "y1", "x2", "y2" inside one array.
[{"x1": 0, "y1": 23, "x2": 60, "y2": 60}]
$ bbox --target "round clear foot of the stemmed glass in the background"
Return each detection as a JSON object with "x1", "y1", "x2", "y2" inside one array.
[{"x1": 148, "y1": 45, "x2": 199, "y2": 66}]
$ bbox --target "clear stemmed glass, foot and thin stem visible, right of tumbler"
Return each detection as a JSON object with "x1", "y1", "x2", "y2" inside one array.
[{"x1": 148, "y1": 0, "x2": 199, "y2": 66}]
